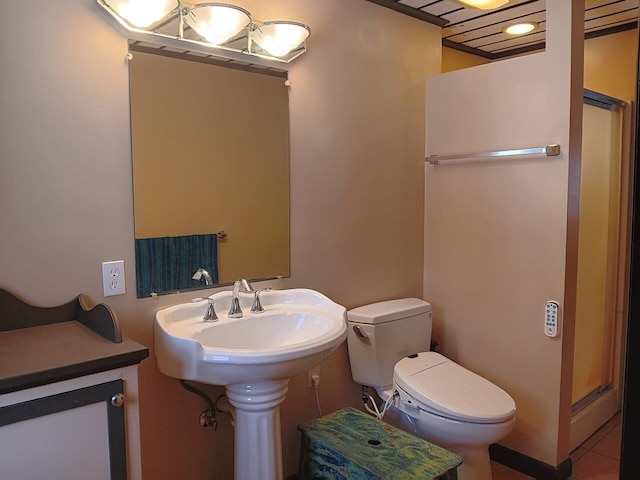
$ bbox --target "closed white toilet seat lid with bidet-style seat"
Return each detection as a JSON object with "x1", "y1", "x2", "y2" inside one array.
[{"x1": 393, "y1": 352, "x2": 516, "y2": 423}]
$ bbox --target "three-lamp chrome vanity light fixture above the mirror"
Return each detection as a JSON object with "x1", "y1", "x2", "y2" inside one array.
[{"x1": 97, "y1": 0, "x2": 311, "y2": 63}]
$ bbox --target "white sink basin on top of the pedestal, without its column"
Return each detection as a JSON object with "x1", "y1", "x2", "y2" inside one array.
[{"x1": 154, "y1": 289, "x2": 347, "y2": 385}]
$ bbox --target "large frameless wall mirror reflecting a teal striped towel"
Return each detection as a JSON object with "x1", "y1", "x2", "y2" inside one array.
[{"x1": 129, "y1": 45, "x2": 289, "y2": 297}]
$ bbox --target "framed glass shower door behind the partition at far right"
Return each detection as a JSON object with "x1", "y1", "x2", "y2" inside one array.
[{"x1": 571, "y1": 90, "x2": 629, "y2": 449}]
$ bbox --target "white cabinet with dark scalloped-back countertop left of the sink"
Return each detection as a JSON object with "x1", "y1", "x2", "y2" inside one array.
[{"x1": 0, "y1": 289, "x2": 149, "y2": 480}]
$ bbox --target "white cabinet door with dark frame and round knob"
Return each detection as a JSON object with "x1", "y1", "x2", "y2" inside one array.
[{"x1": 0, "y1": 380, "x2": 127, "y2": 480}]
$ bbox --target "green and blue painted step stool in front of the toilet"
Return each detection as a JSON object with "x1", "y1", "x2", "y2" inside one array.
[{"x1": 298, "y1": 408, "x2": 462, "y2": 480}]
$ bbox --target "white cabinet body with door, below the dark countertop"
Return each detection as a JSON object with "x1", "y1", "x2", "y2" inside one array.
[{"x1": 0, "y1": 366, "x2": 141, "y2": 480}]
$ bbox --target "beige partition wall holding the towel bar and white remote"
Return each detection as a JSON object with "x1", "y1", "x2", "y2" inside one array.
[{"x1": 424, "y1": 2, "x2": 584, "y2": 466}]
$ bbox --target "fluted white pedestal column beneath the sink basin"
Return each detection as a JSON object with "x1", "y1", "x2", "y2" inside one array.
[{"x1": 227, "y1": 380, "x2": 289, "y2": 480}]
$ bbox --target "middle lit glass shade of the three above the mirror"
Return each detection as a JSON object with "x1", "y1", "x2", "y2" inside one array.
[{"x1": 184, "y1": 3, "x2": 251, "y2": 45}]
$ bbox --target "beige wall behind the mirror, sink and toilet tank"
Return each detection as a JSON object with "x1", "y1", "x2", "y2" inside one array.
[{"x1": 0, "y1": 0, "x2": 441, "y2": 480}]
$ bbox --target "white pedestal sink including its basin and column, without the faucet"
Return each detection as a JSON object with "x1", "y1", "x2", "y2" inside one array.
[{"x1": 154, "y1": 289, "x2": 347, "y2": 480}]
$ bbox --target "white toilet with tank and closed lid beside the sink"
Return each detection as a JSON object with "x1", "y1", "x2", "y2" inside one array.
[{"x1": 347, "y1": 298, "x2": 516, "y2": 480}]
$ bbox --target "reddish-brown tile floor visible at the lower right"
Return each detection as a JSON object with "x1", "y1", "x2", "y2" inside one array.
[{"x1": 491, "y1": 414, "x2": 622, "y2": 480}]
